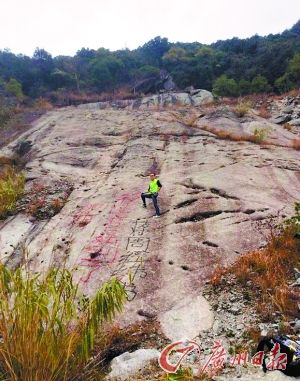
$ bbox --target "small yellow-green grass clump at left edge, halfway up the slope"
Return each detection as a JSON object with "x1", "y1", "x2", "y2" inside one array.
[{"x1": 0, "y1": 167, "x2": 25, "y2": 218}]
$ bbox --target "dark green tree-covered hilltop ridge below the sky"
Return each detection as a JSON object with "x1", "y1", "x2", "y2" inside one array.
[{"x1": 0, "y1": 21, "x2": 300, "y2": 101}]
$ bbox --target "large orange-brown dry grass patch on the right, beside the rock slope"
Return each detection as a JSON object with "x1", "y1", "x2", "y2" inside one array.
[{"x1": 211, "y1": 203, "x2": 300, "y2": 321}]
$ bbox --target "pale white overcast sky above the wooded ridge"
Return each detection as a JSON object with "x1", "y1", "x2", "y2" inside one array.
[{"x1": 0, "y1": 0, "x2": 300, "y2": 56}]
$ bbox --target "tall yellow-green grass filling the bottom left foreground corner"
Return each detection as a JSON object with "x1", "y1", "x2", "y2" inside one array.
[{"x1": 0, "y1": 265, "x2": 126, "y2": 381}]
